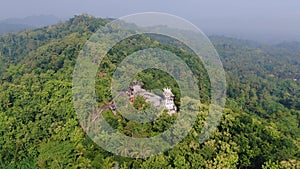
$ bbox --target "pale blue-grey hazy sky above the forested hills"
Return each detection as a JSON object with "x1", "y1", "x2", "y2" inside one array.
[{"x1": 0, "y1": 0, "x2": 300, "y2": 41}]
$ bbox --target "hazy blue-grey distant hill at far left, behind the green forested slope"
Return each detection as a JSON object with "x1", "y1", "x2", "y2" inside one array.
[{"x1": 0, "y1": 15, "x2": 62, "y2": 34}]
